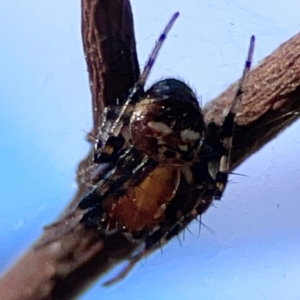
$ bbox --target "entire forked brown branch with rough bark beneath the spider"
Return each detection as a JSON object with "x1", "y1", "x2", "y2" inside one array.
[{"x1": 0, "y1": 0, "x2": 300, "y2": 300}]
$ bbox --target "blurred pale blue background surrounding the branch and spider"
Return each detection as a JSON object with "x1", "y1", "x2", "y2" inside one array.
[{"x1": 0, "y1": 0, "x2": 300, "y2": 300}]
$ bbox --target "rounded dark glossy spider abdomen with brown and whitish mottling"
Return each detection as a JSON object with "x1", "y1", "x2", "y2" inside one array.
[{"x1": 130, "y1": 79, "x2": 204, "y2": 165}]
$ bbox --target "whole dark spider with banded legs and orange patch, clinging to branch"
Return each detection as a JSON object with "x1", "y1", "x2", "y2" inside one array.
[{"x1": 78, "y1": 13, "x2": 255, "y2": 284}]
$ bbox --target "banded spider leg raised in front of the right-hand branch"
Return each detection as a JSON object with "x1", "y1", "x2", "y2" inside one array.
[{"x1": 215, "y1": 35, "x2": 255, "y2": 199}]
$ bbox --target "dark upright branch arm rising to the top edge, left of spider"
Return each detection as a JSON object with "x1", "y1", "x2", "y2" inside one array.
[{"x1": 82, "y1": 0, "x2": 139, "y2": 133}]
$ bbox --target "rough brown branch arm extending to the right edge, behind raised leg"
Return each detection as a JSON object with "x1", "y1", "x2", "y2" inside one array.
[{"x1": 204, "y1": 33, "x2": 300, "y2": 170}]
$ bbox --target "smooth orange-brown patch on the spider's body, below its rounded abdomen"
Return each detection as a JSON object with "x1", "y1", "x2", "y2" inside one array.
[{"x1": 108, "y1": 165, "x2": 180, "y2": 233}]
